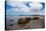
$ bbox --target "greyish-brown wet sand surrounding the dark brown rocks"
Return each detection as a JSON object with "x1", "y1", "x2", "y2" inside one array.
[{"x1": 6, "y1": 16, "x2": 45, "y2": 30}]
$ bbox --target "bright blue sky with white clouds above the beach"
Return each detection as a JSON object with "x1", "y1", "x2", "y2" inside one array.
[{"x1": 6, "y1": 1, "x2": 45, "y2": 16}]
